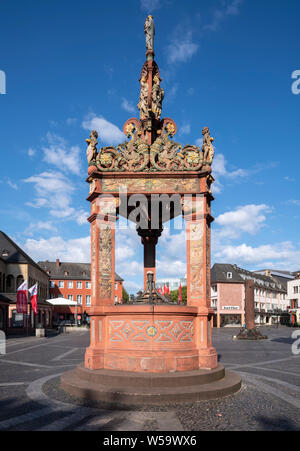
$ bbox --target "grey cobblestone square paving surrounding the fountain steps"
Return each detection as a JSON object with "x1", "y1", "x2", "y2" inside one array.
[{"x1": 0, "y1": 326, "x2": 300, "y2": 431}]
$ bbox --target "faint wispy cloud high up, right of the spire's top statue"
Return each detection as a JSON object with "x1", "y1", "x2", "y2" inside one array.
[{"x1": 167, "y1": 28, "x2": 199, "y2": 64}]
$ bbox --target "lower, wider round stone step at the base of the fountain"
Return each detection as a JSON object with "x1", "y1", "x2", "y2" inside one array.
[{"x1": 61, "y1": 370, "x2": 241, "y2": 407}]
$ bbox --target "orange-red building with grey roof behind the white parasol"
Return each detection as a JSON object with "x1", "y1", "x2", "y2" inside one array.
[{"x1": 38, "y1": 259, "x2": 123, "y2": 324}]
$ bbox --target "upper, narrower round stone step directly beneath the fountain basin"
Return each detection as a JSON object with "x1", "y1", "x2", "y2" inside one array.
[{"x1": 76, "y1": 364, "x2": 225, "y2": 388}]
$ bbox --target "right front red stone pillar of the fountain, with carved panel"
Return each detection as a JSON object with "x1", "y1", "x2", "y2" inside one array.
[{"x1": 183, "y1": 196, "x2": 218, "y2": 369}]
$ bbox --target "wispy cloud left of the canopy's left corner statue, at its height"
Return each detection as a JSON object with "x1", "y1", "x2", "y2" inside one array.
[{"x1": 43, "y1": 133, "x2": 81, "y2": 175}]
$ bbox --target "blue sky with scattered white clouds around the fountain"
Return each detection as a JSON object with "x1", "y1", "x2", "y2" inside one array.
[{"x1": 0, "y1": 0, "x2": 300, "y2": 291}]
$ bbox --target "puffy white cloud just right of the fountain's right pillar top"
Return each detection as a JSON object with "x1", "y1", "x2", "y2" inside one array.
[{"x1": 215, "y1": 204, "x2": 271, "y2": 238}]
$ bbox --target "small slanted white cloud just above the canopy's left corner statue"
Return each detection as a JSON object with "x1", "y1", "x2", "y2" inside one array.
[{"x1": 82, "y1": 114, "x2": 125, "y2": 145}]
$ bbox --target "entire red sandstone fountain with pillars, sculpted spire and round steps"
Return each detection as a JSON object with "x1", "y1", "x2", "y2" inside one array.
[{"x1": 61, "y1": 16, "x2": 241, "y2": 405}]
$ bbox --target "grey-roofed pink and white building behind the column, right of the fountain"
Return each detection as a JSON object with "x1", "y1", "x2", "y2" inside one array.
[{"x1": 211, "y1": 263, "x2": 289, "y2": 327}]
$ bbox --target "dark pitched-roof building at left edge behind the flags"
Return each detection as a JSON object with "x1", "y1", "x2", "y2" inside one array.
[{"x1": 0, "y1": 231, "x2": 52, "y2": 334}]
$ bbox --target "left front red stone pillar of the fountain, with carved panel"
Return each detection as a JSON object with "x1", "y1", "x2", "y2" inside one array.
[{"x1": 85, "y1": 198, "x2": 117, "y2": 369}]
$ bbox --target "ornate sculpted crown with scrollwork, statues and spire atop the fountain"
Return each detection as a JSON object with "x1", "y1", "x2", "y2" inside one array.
[{"x1": 86, "y1": 16, "x2": 214, "y2": 177}]
